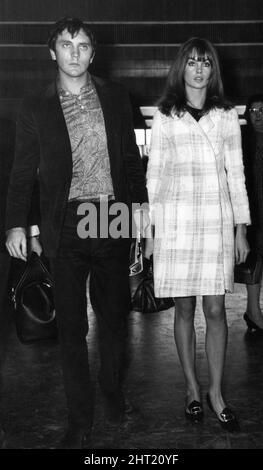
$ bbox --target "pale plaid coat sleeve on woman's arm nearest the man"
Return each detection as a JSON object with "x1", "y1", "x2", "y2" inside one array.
[{"x1": 146, "y1": 111, "x2": 164, "y2": 224}]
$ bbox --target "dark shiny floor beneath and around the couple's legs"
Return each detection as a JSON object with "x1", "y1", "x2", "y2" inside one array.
[{"x1": 2, "y1": 284, "x2": 263, "y2": 449}]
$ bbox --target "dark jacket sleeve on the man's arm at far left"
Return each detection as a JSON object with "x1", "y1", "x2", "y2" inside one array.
[{"x1": 6, "y1": 99, "x2": 39, "y2": 230}]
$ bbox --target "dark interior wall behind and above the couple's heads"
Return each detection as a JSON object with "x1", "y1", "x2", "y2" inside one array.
[{"x1": 0, "y1": 0, "x2": 263, "y2": 127}]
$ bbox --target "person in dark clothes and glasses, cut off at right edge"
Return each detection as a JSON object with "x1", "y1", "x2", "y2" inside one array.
[{"x1": 244, "y1": 94, "x2": 263, "y2": 331}]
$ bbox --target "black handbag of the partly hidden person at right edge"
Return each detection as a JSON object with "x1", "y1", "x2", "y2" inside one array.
[{"x1": 234, "y1": 251, "x2": 262, "y2": 284}]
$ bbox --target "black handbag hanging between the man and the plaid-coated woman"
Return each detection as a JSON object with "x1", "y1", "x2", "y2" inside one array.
[{"x1": 130, "y1": 240, "x2": 174, "y2": 313}]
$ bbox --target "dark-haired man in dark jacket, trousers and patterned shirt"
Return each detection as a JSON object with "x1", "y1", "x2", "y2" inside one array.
[{"x1": 6, "y1": 18, "x2": 149, "y2": 448}]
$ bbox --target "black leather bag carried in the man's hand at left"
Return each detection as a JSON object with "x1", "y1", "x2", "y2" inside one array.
[{"x1": 12, "y1": 252, "x2": 58, "y2": 344}]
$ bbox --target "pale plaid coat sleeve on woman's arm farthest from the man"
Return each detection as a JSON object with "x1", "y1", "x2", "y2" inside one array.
[{"x1": 224, "y1": 109, "x2": 251, "y2": 225}]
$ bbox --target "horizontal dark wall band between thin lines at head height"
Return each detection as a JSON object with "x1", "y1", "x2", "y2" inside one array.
[{"x1": 0, "y1": 20, "x2": 263, "y2": 47}]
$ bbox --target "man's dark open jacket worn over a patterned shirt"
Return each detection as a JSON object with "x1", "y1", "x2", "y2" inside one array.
[{"x1": 6, "y1": 77, "x2": 148, "y2": 257}]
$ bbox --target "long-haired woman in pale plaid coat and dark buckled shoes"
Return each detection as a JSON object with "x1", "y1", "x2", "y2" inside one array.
[{"x1": 146, "y1": 38, "x2": 250, "y2": 431}]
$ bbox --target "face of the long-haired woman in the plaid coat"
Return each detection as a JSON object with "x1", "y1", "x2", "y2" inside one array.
[{"x1": 184, "y1": 51, "x2": 212, "y2": 90}]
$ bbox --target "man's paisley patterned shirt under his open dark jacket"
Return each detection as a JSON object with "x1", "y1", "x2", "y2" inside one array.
[{"x1": 58, "y1": 77, "x2": 114, "y2": 201}]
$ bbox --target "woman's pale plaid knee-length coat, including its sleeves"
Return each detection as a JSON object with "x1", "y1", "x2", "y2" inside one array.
[{"x1": 147, "y1": 109, "x2": 253, "y2": 297}]
